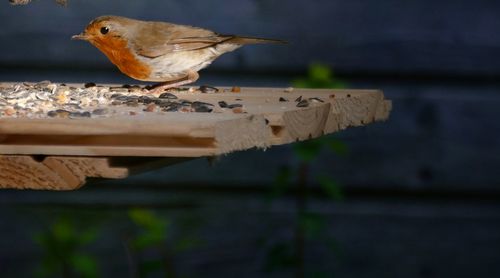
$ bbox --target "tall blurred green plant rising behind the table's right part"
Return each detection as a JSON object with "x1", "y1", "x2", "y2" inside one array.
[{"x1": 264, "y1": 63, "x2": 349, "y2": 277}]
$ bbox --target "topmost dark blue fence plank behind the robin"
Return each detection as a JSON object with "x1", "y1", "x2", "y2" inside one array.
[{"x1": 0, "y1": 0, "x2": 500, "y2": 75}]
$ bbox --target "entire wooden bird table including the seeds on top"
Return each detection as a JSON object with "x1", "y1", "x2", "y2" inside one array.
[{"x1": 0, "y1": 81, "x2": 391, "y2": 190}]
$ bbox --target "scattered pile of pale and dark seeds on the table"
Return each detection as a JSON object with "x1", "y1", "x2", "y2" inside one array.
[{"x1": 0, "y1": 81, "x2": 231, "y2": 118}]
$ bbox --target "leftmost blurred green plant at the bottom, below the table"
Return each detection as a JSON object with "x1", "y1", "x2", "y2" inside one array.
[{"x1": 33, "y1": 214, "x2": 99, "y2": 278}]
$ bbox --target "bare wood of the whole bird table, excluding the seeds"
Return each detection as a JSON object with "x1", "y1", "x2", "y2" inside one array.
[{"x1": 0, "y1": 88, "x2": 391, "y2": 190}]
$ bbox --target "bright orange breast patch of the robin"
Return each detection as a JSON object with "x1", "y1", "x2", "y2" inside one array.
[{"x1": 92, "y1": 37, "x2": 151, "y2": 81}]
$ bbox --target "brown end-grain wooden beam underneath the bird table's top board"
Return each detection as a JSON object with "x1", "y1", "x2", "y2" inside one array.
[{"x1": 0, "y1": 155, "x2": 191, "y2": 190}]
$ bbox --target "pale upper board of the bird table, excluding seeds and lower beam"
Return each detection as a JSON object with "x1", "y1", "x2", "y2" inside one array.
[{"x1": 0, "y1": 88, "x2": 391, "y2": 157}]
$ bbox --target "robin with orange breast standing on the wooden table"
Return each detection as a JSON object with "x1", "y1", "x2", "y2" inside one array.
[{"x1": 72, "y1": 15, "x2": 287, "y2": 93}]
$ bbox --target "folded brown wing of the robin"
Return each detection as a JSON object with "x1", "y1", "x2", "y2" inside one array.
[{"x1": 132, "y1": 22, "x2": 233, "y2": 58}]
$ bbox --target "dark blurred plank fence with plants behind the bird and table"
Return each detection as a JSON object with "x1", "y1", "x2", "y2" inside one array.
[{"x1": 0, "y1": 0, "x2": 500, "y2": 278}]
